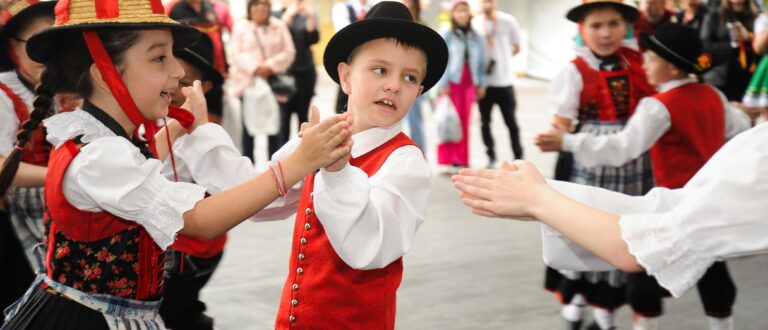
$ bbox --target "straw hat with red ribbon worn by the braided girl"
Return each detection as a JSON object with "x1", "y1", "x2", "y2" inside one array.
[{"x1": 27, "y1": 0, "x2": 200, "y2": 153}]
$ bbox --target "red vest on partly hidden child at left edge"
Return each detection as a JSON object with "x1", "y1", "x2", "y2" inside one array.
[{"x1": 0, "y1": 83, "x2": 51, "y2": 166}]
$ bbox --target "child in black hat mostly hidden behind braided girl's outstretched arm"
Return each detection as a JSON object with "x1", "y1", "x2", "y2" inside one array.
[{"x1": 160, "y1": 34, "x2": 226, "y2": 330}]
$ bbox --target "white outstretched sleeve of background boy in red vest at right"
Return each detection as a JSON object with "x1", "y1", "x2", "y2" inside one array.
[{"x1": 562, "y1": 97, "x2": 672, "y2": 167}]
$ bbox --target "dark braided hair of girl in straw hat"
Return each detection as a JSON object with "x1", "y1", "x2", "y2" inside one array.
[{"x1": 0, "y1": 28, "x2": 139, "y2": 199}]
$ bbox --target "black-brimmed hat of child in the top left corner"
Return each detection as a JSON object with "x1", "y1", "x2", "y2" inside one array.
[{"x1": 0, "y1": 0, "x2": 56, "y2": 71}]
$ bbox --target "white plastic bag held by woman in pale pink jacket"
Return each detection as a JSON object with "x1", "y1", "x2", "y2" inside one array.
[{"x1": 242, "y1": 78, "x2": 280, "y2": 135}]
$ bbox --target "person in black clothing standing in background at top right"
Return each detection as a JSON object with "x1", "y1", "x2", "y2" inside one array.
[{"x1": 701, "y1": 0, "x2": 758, "y2": 101}]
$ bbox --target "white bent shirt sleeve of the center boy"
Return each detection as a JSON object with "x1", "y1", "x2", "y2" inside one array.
[{"x1": 314, "y1": 146, "x2": 431, "y2": 269}]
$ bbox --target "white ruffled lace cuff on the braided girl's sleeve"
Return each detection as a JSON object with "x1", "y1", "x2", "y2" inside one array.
[{"x1": 137, "y1": 182, "x2": 205, "y2": 249}]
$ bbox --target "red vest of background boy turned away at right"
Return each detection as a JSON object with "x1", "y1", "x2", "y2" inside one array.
[{"x1": 651, "y1": 83, "x2": 725, "y2": 189}]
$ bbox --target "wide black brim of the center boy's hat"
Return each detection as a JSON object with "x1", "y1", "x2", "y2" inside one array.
[{"x1": 323, "y1": 18, "x2": 448, "y2": 93}]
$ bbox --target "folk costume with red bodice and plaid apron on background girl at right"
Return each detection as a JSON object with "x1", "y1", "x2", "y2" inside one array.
[{"x1": 545, "y1": 42, "x2": 653, "y2": 320}]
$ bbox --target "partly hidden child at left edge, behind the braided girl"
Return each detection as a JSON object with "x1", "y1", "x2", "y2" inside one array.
[{"x1": 0, "y1": 0, "x2": 55, "y2": 310}]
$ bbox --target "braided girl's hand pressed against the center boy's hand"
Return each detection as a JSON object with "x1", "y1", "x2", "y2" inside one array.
[{"x1": 294, "y1": 107, "x2": 352, "y2": 170}]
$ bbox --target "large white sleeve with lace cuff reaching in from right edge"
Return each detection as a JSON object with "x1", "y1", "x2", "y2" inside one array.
[{"x1": 620, "y1": 124, "x2": 768, "y2": 297}]
